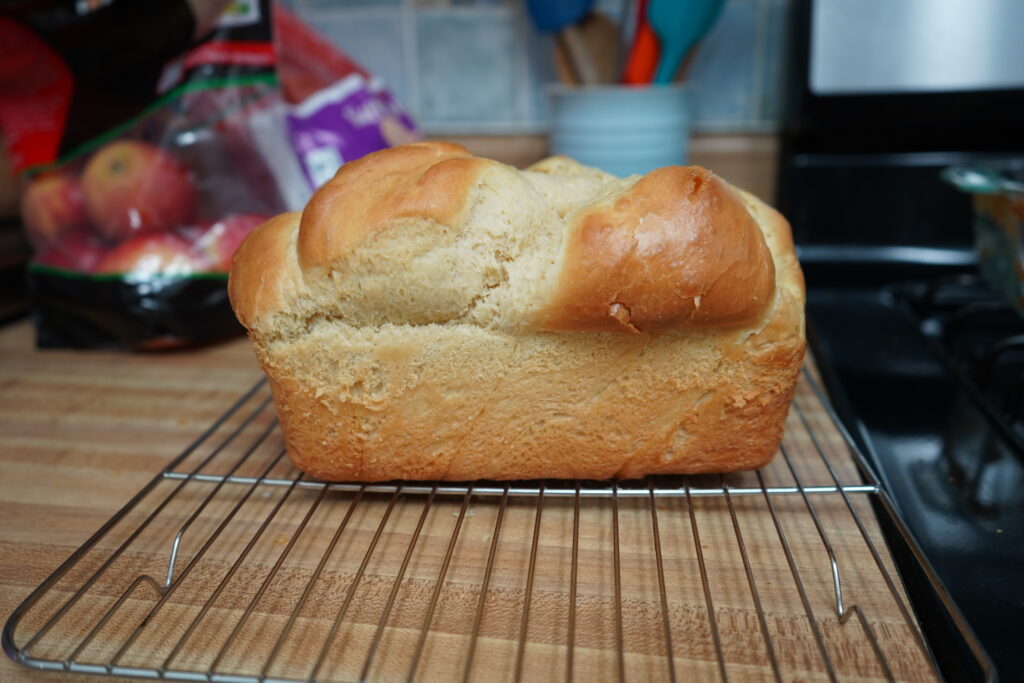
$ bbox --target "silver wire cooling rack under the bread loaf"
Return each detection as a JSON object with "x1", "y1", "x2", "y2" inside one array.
[{"x1": 3, "y1": 373, "x2": 990, "y2": 683}]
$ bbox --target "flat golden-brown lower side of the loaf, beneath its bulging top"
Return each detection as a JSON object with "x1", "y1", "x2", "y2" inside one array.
[{"x1": 268, "y1": 329, "x2": 803, "y2": 481}]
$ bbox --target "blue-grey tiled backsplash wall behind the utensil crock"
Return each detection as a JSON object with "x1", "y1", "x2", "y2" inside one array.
[{"x1": 286, "y1": 0, "x2": 791, "y2": 134}]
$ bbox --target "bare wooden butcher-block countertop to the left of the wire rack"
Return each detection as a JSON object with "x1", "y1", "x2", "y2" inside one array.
[{"x1": 0, "y1": 321, "x2": 260, "y2": 681}]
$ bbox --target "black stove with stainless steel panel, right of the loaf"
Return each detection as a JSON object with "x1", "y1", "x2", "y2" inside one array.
[{"x1": 779, "y1": 0, "x2": 1024, "y2": 680}]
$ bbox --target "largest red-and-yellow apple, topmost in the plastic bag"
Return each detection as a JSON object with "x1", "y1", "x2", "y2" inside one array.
[{"x1": 82, "y1": 140, "x2": 196, "y2": 242}]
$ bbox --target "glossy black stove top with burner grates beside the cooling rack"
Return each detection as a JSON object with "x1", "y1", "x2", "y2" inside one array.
[{"x1": 808, "y1": 273, "x2": 1024, "y2": 681}]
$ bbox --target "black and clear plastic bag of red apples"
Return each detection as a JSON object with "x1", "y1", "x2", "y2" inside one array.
[{"x1": 0, "y1": 0, "x2": 287, "y2": 349}]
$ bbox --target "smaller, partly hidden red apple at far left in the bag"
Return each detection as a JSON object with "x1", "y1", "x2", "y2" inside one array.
[{"x1": 22, "y1": 172, "x2": 89, "y2": 245}]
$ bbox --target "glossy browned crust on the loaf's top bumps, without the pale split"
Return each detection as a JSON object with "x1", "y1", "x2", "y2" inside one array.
[{"x1": 232, "y1": 142, "x2": 775, "y2": 334}]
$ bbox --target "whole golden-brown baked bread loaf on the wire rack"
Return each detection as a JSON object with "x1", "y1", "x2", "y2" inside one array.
[{"x1": 229, "y1": 142, "x2": 805, "y2": 481}]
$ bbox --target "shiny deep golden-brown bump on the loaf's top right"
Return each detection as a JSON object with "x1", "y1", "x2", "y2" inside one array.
[{"x1": 540, "y1": 166, "x2": 775, "y2": 333}]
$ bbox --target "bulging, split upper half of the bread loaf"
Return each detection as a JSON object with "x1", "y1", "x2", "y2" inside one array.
[{"x1": 229, "y1": 142, "x2": 782, "y2": 343}]
